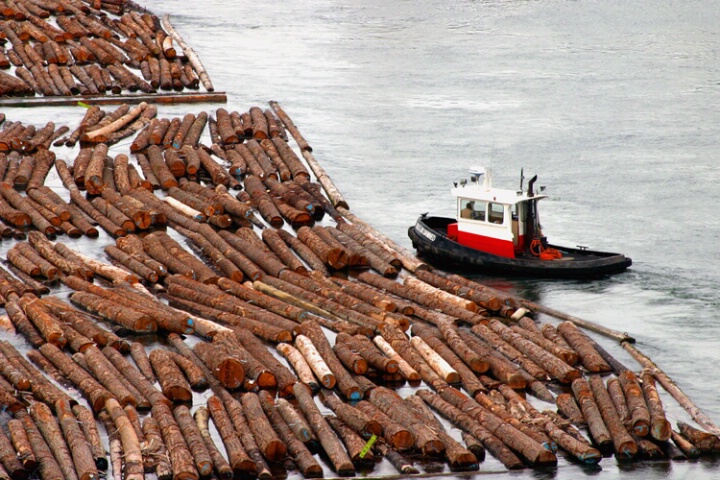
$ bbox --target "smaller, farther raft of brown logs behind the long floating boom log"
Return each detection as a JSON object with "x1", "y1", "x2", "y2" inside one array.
[{"x1": 0, "y1": 1, "x2": 214, "y2": 100}]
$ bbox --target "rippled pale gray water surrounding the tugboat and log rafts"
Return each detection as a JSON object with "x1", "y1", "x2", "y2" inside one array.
[{"x1": 6, "y1": 0, "x2": 720, "y2": 480}]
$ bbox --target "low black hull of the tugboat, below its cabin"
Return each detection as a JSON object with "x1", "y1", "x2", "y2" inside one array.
[{"x1": 408, "y1": 217, "x2": 632, "y2": 278}]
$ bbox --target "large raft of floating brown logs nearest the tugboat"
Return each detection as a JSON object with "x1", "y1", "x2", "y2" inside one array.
[{"x1": 0, "y1": 104, "x2": 720, "y2": 480}]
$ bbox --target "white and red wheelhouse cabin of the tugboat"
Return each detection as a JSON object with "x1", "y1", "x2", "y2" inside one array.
[{"x1": 448, "y1": 167, "x2": 547, "y2": 258}]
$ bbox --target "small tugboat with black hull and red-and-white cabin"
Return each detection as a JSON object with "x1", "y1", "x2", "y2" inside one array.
[{"x1": 408, "y1": 167, "x2": 632, "y2": 279}]
